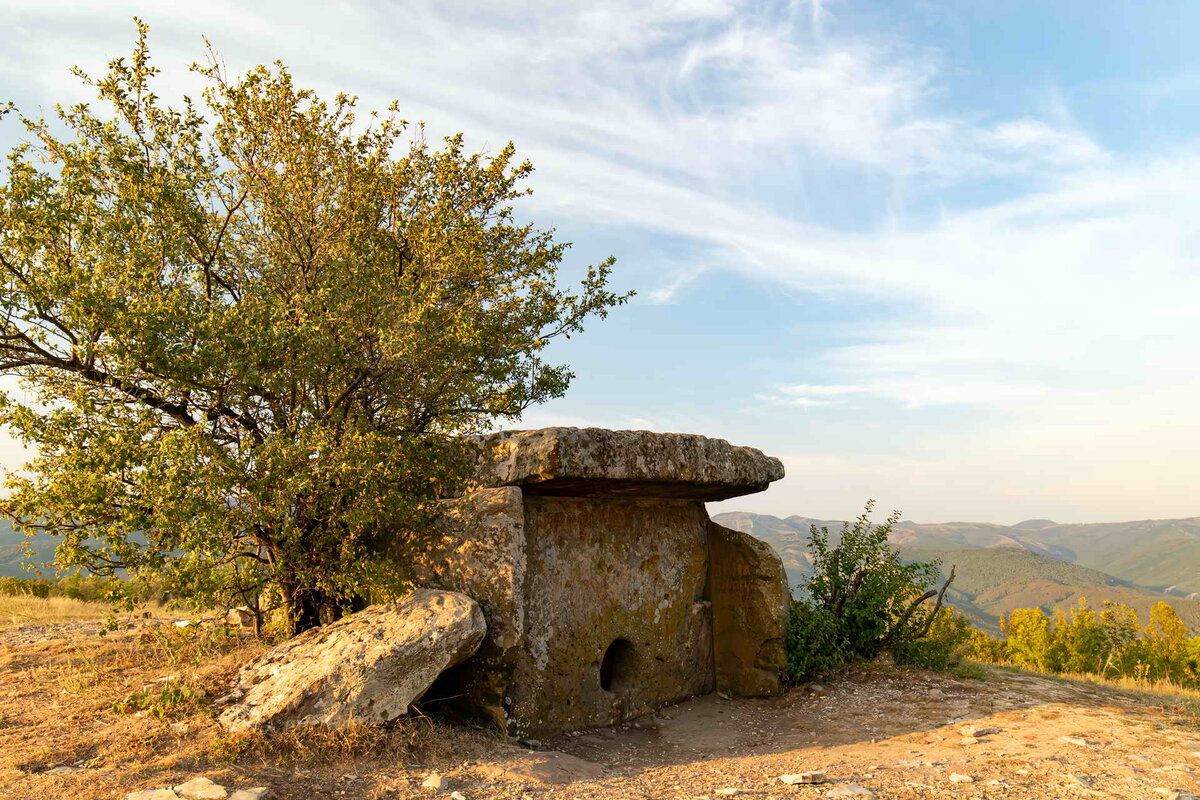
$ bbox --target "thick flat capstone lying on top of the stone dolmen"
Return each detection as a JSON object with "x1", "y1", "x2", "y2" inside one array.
[{"x1": 479, "y1": 428, "x2": 784, "y2": 500}]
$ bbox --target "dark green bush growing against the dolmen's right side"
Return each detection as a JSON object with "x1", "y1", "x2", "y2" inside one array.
[{"x1": 786, "y1": 503, "x2": 950, "y2": 681}]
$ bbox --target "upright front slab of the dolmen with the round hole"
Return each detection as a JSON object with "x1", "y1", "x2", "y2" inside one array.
[{"x1": 509, "y1": 495, "x2": 713, "y2": 735}]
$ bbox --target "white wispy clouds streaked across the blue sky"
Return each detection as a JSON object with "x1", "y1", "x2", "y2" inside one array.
[{"x1": 0, "y1": 0, "x2": 1200, "y2": 525}]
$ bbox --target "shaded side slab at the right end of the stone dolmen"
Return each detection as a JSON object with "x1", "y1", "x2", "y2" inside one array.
[{"x1": 708, "y1": 522, "x2": 791, "y2": 697}]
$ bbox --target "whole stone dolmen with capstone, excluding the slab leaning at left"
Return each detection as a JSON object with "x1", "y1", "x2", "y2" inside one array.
[{"x1": 408, "y1": 428, "x2": 787, "y2": 735}]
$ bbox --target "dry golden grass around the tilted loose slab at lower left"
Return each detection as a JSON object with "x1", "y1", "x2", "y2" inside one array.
[{"x1": 0, "y1": 614, "x2": 504, "y2": 800}]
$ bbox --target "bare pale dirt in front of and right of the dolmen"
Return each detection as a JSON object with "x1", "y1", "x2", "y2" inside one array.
[{"x1": 446, "y1": 669, "x2": 1200, "y2": 800}]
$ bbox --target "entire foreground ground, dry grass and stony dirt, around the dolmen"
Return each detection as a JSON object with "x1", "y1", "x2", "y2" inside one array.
[{"x1": 0, "y1": 627, "x2": 1200, "y2": 800}]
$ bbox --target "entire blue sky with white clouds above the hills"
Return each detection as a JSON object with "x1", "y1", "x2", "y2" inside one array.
[{"x1": 0, "y1": 0, "x2": 1200, "y2": 523}]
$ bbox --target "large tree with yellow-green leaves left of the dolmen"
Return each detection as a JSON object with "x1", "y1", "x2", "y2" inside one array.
[{"x1": 0, "y1": 20, "x2": 628, "y2": 631}]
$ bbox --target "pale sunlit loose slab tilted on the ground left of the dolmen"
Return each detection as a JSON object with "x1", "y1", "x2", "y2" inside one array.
[{"x1": 220, "y1": 589, "x2": 486, "y2": 730}]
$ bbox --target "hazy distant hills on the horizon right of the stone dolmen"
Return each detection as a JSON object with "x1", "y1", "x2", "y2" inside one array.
[{"x1": 713, "y1": 512, "x2": 1200, "y2": 631}]
